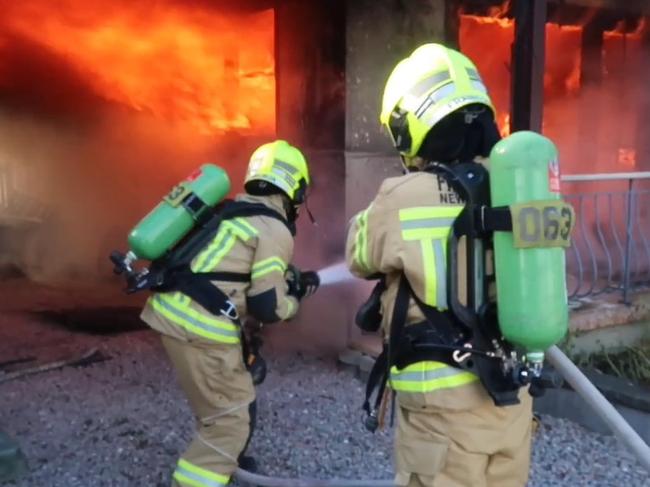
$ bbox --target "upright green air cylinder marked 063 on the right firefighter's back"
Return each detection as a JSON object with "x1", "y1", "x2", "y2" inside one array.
[{"x1": 490, "y1": 131, "x2": 574, "y2": 363}]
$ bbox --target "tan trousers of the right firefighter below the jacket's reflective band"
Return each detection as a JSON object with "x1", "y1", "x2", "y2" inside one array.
[{"x1": 395, "y1": 382, "x2": 532, "y2": 487}]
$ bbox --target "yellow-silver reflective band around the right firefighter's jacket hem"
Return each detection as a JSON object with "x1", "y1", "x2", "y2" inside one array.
[{"x1": 390, "y1": 361, "x2": 478, "y2": 393}]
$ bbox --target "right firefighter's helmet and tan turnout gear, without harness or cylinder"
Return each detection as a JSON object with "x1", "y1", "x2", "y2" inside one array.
[{"x1": 346, "y1": 44, "x2": 532, "y2": 487}]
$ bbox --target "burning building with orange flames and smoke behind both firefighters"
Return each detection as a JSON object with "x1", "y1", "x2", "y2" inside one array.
[{"x1": 0, "y1": 0, "x2": 650, "y2": 352}]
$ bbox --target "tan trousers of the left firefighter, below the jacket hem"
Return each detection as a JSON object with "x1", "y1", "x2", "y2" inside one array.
[{"x1": 162, "y1": 335, "x2": 255, "y2": 487}]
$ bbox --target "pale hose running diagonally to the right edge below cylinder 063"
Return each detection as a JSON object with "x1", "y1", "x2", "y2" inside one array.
[{"x1": 546, "y1": 346, "x2": 650, "y2": 472}]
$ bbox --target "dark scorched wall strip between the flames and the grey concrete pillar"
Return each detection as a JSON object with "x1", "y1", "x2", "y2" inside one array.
[{"x1": 267, "y1": 0, "x2": 349, "y2": 354}]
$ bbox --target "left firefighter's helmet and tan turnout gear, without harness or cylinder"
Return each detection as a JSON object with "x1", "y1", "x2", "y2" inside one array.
[{"x1": 142, "y1": 141, "x2": 317, "y2": 487}]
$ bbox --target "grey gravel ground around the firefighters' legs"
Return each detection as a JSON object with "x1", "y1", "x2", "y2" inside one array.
[{"x1": 0, "y1": 320, "x2": 650, "y2": 487}]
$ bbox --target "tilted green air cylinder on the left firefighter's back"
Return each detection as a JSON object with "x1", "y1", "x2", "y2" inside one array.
[{"x1": 129, "y1": 164, "x2": 230, "y2": 260}]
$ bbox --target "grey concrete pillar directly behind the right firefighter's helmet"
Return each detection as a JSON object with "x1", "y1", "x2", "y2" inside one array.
[{"x1": 345, "y1": 0, "x2": 450, "y2": 348}]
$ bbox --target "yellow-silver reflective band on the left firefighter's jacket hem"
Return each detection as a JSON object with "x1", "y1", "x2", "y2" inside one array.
[{"x1": 150, "y1": 293, "x2": 241, "y2": 344}]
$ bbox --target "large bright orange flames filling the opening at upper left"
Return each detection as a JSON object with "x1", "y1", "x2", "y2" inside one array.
[{"x1": 0, "y1": 0, "x2": 275, "y2": 134}]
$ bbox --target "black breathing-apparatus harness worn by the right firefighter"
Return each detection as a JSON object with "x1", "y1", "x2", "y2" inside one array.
[{"x1": 356, "y1": 162, "x2": 557, "y2": 431}]
